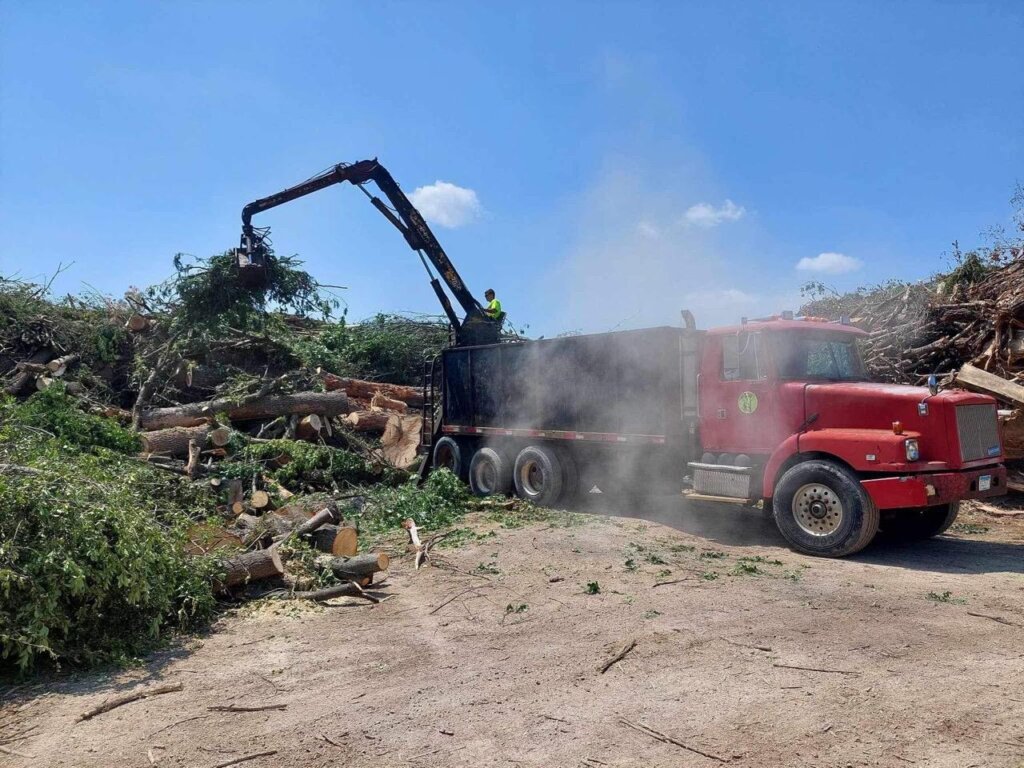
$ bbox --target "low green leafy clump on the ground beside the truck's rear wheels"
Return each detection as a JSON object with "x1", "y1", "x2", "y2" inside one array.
[{"x1": 362, "y1": 469, "x2": 470, "y2": 534}]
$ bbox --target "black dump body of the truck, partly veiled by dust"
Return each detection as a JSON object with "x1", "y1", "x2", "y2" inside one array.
[{"x1": 441, "y1": 327, "x2": 700, "y2": 444}]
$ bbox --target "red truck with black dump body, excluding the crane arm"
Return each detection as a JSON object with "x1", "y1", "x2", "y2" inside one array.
[{"x1": 424, "y1": 312, "x2": 1006, "y2": 557}]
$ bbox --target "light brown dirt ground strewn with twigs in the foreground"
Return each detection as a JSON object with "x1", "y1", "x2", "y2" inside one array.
[{"x1": 0, "y1": 500, "x2": 1024, "y2": 768}]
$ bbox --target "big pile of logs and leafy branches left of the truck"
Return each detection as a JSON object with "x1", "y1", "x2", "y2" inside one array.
[{"x1": 0, "y1": 253, "x2": 466, "y2": 670}]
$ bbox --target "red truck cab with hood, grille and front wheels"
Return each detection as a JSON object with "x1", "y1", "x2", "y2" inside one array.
[{"x1": 689, "y1": 318, "x2": 1006, "y2": 555}]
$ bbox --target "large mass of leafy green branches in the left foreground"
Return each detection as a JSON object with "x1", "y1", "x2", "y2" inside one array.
[{"x1": 0, "y1": 397, "x2": 214, "y2": 673}]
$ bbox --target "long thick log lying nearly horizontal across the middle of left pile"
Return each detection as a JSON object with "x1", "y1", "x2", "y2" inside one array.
[{"x1": 140, "y1": 392, "x2": 350, "y2": 430}]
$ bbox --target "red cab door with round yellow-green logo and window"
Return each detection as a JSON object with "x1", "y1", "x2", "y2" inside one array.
[{"x1": 700, "y1": 331, "x2": 778, "y2": 455}]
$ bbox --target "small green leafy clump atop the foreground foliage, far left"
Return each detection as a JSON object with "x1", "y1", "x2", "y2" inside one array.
[{"x1": 18, "y1": 382, "x2": 140, "y2": 454}]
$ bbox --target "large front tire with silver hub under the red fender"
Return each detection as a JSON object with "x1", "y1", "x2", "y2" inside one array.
[{"x1": 772, "y1": 460, "x2": 879, "y2": 557}]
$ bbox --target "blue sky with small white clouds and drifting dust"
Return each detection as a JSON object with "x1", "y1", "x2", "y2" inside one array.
[{"x1": 0, "y1": 0, "x2": 1024, "y2": 334}]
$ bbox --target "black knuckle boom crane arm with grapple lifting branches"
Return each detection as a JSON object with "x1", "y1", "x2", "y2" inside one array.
[{"x1": 236, "y1": 159, "x2": 502, "y2": 346}]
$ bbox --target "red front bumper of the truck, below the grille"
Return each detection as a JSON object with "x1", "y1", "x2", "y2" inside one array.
[{"x1": 860, "y1": 464, "x2": 1007, "y2": 509}]
